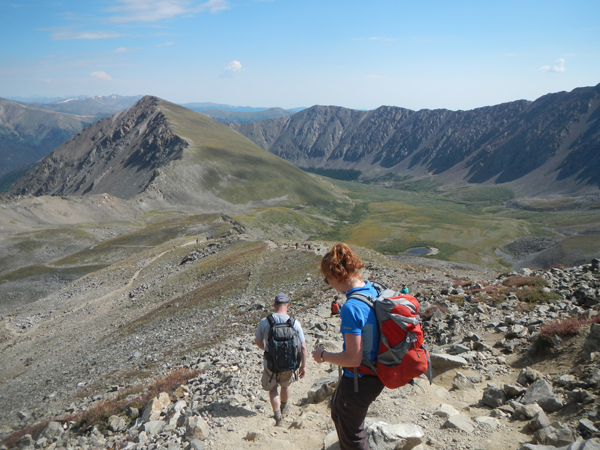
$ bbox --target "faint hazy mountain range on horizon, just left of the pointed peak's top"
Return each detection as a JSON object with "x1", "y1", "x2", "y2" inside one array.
[{"x1": 20, "y1": 94, "x2": 142, "y2": 118}]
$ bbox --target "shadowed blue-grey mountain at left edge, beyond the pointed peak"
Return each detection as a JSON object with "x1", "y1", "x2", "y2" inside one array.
[{"x1": 0, "y1": 98, "x2": 94, "y2": 177}]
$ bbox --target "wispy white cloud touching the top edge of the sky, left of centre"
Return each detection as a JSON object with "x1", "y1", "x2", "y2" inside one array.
[{"x1": 107, "y1": 0, "x2": 229, "y2": 22}]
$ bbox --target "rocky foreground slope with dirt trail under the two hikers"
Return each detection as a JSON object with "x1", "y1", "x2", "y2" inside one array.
[{"x1": 0, "y1": 230, "x2": 600, "y2": 450}]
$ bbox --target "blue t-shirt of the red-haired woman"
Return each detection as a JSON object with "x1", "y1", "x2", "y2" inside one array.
[{"x1": 340, "y1": 281, "x2": 379, "y2": 377}]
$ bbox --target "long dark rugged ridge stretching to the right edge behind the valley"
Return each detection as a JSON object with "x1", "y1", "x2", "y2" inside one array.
[{"x1": 231, "y1": 85, "x2": 600, "y2": 195}]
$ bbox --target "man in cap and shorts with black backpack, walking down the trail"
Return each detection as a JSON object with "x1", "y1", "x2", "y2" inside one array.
[{"x1": 254, "y1": 294, "x2": 308, "y2": 426}]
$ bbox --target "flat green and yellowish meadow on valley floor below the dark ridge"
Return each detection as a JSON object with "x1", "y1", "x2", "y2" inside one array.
[{"x1": 247, "y1": 177, "x2": 600, "y2": 269}]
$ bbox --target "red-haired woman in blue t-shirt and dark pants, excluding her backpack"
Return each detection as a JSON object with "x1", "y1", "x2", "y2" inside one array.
[{"x1": 312, "y1": 244, "x2": 384, "y2": 450}]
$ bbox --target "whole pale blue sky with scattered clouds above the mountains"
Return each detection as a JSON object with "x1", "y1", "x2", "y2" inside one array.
[{"x1": 0, "y1": 0, "x2": 600, "y2": 110}]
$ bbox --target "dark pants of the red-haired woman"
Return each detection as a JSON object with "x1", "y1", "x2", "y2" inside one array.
[{"x1": 331, "y1": 375, "x2": 384, "y2": 450}]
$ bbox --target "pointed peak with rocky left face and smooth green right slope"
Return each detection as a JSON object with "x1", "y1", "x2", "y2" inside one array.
[{"x1": 9, "y1": 96, "x2": 332, "y2": 210}]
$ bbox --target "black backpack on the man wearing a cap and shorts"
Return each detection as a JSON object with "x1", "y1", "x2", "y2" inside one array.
[{"x1": 265, "y1": 314, "x2": 302, "y2": 373}]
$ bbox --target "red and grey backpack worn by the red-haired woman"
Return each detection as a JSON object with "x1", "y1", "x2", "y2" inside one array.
[{"x1": 350, "y1": 281, "x2": 432, "y2": 391}]
